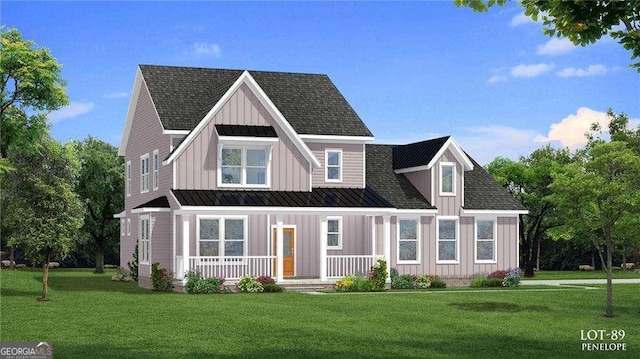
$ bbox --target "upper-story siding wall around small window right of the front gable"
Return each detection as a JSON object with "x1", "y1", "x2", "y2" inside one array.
[{"x1": 307, "y1": 142, "x2": 365, "y2": 188}]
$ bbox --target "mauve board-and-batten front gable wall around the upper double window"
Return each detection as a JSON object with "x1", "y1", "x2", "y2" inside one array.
[{"x1": 175, "y1": 85, "x2": 309, "y2": 191}]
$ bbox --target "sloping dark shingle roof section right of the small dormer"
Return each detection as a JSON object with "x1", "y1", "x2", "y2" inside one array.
[{"x1": 464, "y1": 154, "x2": 527, "y2": 210}]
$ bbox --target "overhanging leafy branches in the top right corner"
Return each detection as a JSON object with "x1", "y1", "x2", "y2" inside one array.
[{"x1": 454, "y1": 0, "x2": 640, "y2": 72}]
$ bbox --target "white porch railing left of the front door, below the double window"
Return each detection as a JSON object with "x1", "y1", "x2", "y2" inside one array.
[{"x1": 189, "y1": 256, "x2": 276, "y2": 279}]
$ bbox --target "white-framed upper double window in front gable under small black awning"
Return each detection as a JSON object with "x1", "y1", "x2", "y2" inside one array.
[{"x1": 218, "y1": 146, "x2": 270, "y2": 187}]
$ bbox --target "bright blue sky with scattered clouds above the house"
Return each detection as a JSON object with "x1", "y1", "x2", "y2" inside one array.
[{"x1": 0, "y1": 0, "x2": 640, "y2": 164}]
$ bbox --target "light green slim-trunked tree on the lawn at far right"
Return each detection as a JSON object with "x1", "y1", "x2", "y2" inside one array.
[{"x1": 549, "y1": 141, "x2": 640, "y2": 317}]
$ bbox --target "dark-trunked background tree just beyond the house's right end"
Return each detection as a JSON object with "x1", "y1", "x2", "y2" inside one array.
[{"x1": 487, "y1": 146, "x2": 571, "y2": 277}]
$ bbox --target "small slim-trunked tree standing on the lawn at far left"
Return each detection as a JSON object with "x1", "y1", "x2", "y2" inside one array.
[{"x1": 5, "y1": 136, "x2": 83, "y2": 300}]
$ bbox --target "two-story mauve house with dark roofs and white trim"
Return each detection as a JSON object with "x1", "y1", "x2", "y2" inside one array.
[{"x1": 118, "y1": 65, "x2": 526, "y2": 286}]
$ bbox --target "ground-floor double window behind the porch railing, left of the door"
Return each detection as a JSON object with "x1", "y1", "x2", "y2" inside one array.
[{"x1": 197, "y1": 216, "x2": 247, "y2": 257}]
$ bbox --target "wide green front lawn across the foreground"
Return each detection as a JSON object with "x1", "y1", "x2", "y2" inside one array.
[{"x1": 0, "y1": 269, "x2": 640, "y2": 358}]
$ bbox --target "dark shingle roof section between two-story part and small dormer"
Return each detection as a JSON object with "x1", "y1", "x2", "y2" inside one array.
[{"x1": 366, "y1": 145, "x2": 435, "y2": 209}]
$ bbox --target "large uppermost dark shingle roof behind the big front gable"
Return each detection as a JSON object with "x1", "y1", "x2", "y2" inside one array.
[{"x1": 140, "y1": 65, "x2": 372, "y2": 136}]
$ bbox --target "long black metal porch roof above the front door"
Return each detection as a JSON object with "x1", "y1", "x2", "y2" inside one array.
[{"x1": 171, "y1": 188, "x2": 393, "y2": 208}]
